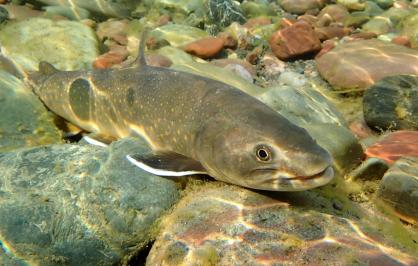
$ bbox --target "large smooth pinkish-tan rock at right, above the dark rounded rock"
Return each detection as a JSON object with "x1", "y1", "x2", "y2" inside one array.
[{"x1": 316, "y1": 39, "x2": 418, "y2": 90}]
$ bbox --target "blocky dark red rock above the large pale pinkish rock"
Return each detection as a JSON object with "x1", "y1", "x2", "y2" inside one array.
[{"x1": 269, "y1": 21, "x2": 321, "y2": 59}]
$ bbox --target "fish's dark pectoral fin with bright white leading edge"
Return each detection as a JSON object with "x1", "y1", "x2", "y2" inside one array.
[{"x1": 126, "y1": 152, "x2": 207, "y2": 176}]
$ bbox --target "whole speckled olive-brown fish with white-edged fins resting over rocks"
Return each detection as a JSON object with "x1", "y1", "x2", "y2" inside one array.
[{"x1": 28, "y1": 33, "x2": 334, "y2": 191}]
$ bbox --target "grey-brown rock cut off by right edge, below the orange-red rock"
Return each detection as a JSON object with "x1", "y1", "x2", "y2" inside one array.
[{"x1": 377, "y1": 157, "x2": 418, "y2": 224}]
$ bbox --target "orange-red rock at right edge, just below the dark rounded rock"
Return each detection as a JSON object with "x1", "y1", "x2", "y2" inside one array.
[{"x1": 365, "y1": 130, "x2": 418, "y2": 164}]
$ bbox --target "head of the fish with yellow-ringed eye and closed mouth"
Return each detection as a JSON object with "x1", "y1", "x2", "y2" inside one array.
[{"x1": 194, "y1": 113, "x2": 334, "y2": 191}]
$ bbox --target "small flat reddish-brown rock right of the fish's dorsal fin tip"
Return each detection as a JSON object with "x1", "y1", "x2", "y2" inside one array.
[{"x1": 183, "y1": 37, "x2": 224, "y2": 59}]
